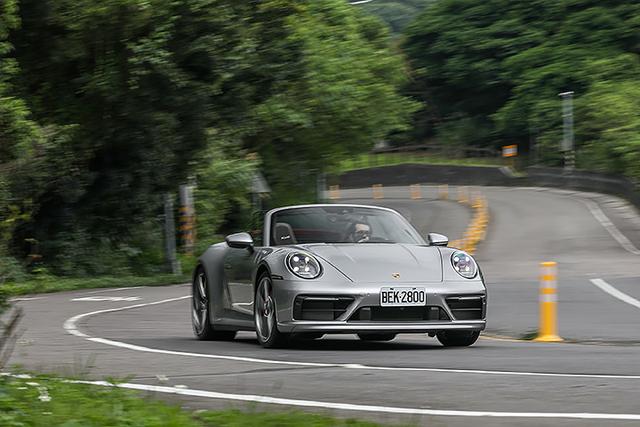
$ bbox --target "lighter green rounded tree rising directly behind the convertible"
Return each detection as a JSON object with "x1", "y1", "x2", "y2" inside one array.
[{"x1": 245, "y1": 0, "x2": 416, "y2": 203}]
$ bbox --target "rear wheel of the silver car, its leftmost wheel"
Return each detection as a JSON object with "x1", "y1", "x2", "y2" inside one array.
[{"x1": 191, "y1": 267, "x2": 236, "y2": 341}]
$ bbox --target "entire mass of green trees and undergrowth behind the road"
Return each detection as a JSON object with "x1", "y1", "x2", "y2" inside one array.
[{"x1": 0, "y1": 0, "x2": 640, "y2": 300}]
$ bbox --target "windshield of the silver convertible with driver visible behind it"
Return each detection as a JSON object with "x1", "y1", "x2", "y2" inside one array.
[{"x1": 271, "y1": 206, "x2": 424, "y2": 246}]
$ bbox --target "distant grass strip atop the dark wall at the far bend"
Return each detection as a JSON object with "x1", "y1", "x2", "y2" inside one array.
[{"x1": 331, "y1": 153, "x2": 505, "y2": 175}]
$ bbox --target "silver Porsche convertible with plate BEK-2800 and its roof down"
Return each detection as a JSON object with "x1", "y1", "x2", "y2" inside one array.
[{"x1": 192, "y1": 204, "x2": 487, "y2": 347}]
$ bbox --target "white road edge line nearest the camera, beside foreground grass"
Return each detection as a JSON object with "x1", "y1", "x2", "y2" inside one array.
[{"x1": 56, "y1": 381, "x2": 640, "y2": 421}]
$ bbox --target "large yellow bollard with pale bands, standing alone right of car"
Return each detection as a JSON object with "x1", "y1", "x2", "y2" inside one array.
[{"x1": 534, "y1": 262, "x2": 562, "y2": 342}]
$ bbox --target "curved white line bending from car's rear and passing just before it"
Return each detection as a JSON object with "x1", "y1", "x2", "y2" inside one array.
[{"x1": 63, "y1": 295, "x2": 640, "y2": 380}]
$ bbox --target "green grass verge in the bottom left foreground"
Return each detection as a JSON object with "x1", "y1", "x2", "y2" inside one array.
[{"x1": 0, "y1": 376, "x2": 379, "y2": 427}]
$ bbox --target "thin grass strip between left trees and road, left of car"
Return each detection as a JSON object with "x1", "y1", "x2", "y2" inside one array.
[{"x1": 0, "y1": 271, "x2": 191, "y2": 296}]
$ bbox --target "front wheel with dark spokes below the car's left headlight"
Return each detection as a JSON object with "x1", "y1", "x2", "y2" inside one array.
[{"x1": 253, "y1": 273, "x2": 290, "y2": 348}]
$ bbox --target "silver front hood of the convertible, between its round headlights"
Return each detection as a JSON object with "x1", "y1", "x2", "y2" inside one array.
[{"x1": 303, "y1": 243, "x2": 442, "y2": 284}]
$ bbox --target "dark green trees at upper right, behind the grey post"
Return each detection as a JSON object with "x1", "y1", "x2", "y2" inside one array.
[{"x1": 405, "y1": 0, "x2": 640, "y2": 179}]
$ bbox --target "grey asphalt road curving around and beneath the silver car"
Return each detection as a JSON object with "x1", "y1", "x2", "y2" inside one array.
[{"x1": 12, "y1": 188, "x2": 640, "y2": 426}]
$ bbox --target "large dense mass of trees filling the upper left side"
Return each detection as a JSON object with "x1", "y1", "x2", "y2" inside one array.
[{"x1": 0, "y1": 0, "x2": 415, "y2": 278}]
